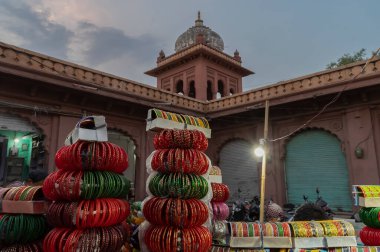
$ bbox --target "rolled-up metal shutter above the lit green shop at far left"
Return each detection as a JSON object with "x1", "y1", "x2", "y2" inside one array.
[{"x1": 0, "y1": 113, "x2": 38, "y2": 132}]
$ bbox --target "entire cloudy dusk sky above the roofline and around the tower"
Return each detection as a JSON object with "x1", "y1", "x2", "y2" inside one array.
[{"x1": 0, "y1": 0, "x2": 380, "y2": 90}]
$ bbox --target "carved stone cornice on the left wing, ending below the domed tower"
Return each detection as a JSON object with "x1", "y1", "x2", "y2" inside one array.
[{"x1": 0, "y1": 42, "x2": 206, "y2": 113}]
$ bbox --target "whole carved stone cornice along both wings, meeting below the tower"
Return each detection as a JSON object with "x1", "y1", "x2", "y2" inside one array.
[{"x1": 0, "y1": 42, "x2": 380, "y2": 117}]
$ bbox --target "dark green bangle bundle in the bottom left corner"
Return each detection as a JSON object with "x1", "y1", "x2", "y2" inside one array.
[{"x1": 0, "y1": 214, "x2": 47, "y2": 244}]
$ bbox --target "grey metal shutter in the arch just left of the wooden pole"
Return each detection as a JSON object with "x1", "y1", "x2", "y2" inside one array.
[{"x1": 219, "y1": 140, "x2": 259, "y2": 205}]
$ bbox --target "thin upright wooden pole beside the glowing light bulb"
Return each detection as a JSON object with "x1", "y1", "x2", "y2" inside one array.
[{"x1": 260, "y1": 100, "x2": 269, "y2": 223}]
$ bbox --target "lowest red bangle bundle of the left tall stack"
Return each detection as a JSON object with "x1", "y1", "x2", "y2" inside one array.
[{"x1": 43, "y1": 225, "x2": 126, "y2": 252}]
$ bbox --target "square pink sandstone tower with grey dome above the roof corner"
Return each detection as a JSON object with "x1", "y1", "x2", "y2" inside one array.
[{"x1": 145, "y1": 12, "x2": 253, "y2": 101}]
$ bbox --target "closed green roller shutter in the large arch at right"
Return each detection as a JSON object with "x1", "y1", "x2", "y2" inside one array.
[{"x1": 285, "y1": 130, "x2": 352, "y2": 211}]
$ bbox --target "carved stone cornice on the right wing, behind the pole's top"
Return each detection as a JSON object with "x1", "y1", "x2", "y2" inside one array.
[{"x1": 206, "y1": 57, "x2": 380, "y2": 117}]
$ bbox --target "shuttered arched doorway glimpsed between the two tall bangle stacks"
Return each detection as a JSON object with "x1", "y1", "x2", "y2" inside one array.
[{"x1": 108, "y1": 129, "x2": 136, "y2": 197}]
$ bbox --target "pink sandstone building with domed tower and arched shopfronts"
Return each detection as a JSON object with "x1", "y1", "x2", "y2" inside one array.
[{"x1": 0, "y1": 13, "x2": 380, "y2": 212}]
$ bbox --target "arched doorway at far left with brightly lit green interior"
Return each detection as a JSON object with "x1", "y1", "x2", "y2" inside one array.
[{"x1": 0, "y1": 113, "x2": 47, "y2": 186}]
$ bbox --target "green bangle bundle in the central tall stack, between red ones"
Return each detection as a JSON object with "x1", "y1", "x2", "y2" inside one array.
[{"x1": 149, "y1": 173, "x2": 208, "y2": 199}]
